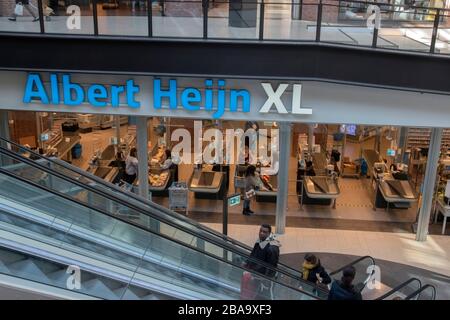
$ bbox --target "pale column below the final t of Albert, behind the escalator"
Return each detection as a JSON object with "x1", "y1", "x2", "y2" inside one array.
[{"x1": 136, "y1": 117, "x2": 148, "y2": 199}]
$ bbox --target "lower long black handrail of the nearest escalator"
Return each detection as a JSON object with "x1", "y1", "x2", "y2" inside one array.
[{"x1": 0, "y1": 161, "x2": 320, "y2": 299}]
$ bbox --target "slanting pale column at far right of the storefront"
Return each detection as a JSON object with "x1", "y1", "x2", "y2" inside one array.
[{"x1": 416, "y1": 128, "x2": 442, "y2": 241}]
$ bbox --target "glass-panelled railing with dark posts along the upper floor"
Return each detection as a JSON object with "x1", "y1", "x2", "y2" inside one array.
[{"x1": 0, "y1": 0, "x2": 450, "y2": 54}]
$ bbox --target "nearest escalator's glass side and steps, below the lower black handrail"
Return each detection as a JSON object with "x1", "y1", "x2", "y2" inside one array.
[{"x1": 0, "y1": 169, "x2": 317, "y2": 300}]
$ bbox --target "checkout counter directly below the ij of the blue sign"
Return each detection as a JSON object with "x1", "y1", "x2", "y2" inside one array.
[{"x1": 189, "y1": 165, "x2": 230, "y2": 199}]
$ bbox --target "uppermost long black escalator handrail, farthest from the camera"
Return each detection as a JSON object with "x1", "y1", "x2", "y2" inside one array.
[{"x1": 0, "y1": 137, "x2": 292, "y2": 272}]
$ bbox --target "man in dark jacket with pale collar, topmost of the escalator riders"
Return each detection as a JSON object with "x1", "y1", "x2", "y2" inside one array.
[{"x1": 247, "y1": 224, "x2": 281, "y2": 277}]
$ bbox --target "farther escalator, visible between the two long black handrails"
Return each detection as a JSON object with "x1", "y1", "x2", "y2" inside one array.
[{"x1": 0, "y1": 140, "x2": 327, "y2": 297}]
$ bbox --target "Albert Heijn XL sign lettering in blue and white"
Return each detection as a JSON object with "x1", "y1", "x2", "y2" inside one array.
[{"x1": 23, "y1": 73, "x2": 312, "y2": 119}]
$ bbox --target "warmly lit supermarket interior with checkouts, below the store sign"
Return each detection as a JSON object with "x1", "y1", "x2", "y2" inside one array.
[{"x1": 9, "y1": 112, "x2": 450, "y2": 234}]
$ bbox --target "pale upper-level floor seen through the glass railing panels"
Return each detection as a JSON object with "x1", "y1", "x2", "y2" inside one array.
[{"x1": 0, "y1": 10, "x2": 450, "y2": 53}]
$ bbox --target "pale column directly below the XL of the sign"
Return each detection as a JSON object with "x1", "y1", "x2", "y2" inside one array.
[{"x1": 275, "y1": 122, "x2": 291, "y2": 234}]
